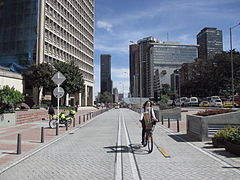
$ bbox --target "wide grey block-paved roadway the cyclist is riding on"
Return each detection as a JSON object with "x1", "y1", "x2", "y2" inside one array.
[{"x1": 0, "y1": 109, "x2": 240, "y2": 180}]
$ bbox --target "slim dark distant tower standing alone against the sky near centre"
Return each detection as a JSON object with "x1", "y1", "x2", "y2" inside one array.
[{"x1": 101, "y1": 54, "x2": 112, "y2": 94}]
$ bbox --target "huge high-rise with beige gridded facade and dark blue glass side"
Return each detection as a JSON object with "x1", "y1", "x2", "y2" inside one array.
[{"x1": 0, "y1": 0, "x2": 94, "y2": 106}]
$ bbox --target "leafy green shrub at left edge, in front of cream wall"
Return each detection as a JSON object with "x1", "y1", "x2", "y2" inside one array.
[{"x1": 0, "y1": 86, "x2": 24, "y2": 113}]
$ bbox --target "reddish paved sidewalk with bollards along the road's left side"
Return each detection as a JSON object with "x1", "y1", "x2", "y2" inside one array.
[{"x1": 0, "y1": 108, "x2": 100, "y2": 169}]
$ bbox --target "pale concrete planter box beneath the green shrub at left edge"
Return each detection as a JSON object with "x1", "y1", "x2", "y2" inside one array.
[{"x1": 0, "y1": 113, "x2": 16, "y2": 128}]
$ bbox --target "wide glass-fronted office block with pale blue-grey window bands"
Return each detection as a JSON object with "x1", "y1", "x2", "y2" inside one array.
[{"x1": 152, "y1": 42, "x2": 198, "y2": 96}]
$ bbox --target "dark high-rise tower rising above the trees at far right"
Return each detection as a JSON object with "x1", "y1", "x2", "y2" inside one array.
[{"x1": 197, "y1": 27, "x2": 223, "y2": 60}]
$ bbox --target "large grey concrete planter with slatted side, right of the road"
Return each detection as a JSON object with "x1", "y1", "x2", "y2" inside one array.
[{"x1": 187, "y1": 111, "x2": 240, "y2": 141}]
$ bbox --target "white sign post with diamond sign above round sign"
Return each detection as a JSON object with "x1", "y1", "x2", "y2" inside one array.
[{"x1": 52, "y1": 71, "x2": 66, "y2": 128}]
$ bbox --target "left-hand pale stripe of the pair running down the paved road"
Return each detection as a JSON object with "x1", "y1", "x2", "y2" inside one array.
[{"x1": 115, "y1": 114, "x2": 122, "y2": 180}]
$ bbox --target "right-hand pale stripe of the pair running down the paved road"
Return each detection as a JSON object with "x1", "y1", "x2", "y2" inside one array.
[{"x1": 121, "y1": 113, "x2": 141, "y2": 180}]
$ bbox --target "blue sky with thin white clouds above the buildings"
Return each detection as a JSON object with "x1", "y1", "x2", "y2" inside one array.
[{"x1": 94, "y1": 0, "x2": 240, "y2": 97}]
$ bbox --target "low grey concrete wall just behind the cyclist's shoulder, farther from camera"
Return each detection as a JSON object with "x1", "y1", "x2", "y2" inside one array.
[{"x1": 154, "y1": 107, "x2": 181, "y2": 121}]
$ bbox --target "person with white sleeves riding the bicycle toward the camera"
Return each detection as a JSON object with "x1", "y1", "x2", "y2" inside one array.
[{"x1": 140, "y1": 101, "x2": 157, "y2": 145}]
